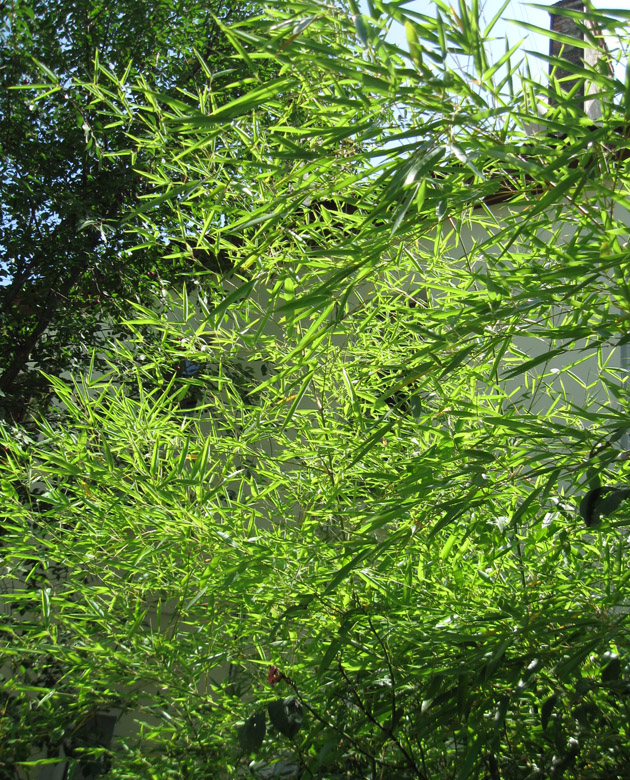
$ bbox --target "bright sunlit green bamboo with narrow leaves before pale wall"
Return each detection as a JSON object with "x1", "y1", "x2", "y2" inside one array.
[{"x1": 0, "y1": 0, "x2": 630, "y2": 780}]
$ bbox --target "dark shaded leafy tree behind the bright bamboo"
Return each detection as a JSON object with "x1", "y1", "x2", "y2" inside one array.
[{"x1": 0, "y1": 0, "x2": 262, "y2": 420}]
